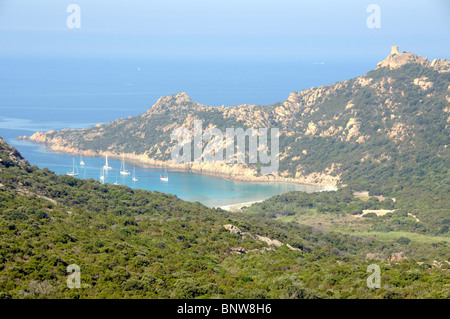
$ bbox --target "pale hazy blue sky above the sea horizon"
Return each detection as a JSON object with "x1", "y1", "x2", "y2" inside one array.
[{"x1": 0, "y1": 0, "x2": 450, "y2": 60}]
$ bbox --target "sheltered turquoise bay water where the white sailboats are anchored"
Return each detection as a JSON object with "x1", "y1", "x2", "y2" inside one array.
[{"x1": 7, "y1": 138, "x2": 321, "y2": 207}]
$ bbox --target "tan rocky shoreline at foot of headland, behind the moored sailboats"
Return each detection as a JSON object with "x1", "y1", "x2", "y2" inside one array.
[{"x1": 17, "y1": 136, "x2": 338, "y2": 191}]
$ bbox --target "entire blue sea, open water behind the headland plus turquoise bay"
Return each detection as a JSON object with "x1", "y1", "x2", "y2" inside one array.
[{"x1": 0, "y1": 55, "x2": 376, "y2": 207}]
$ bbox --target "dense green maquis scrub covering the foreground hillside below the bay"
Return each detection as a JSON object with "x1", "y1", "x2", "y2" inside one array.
[{"x1": 0, "y1": 139, "x2": 450, "y2": 298}]
